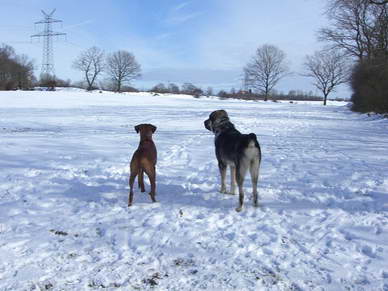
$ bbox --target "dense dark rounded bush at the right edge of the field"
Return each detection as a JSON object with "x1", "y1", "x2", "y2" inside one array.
[{"x1": 351, "y1": 57, "x2": 388, "y2": 113}]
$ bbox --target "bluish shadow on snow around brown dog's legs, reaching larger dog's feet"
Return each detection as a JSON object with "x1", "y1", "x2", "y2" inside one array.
[{"x1": 50, "y1": 176, "x2": 233, "y2": 209}]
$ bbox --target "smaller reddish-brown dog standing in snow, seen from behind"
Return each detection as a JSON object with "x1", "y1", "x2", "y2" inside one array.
[{"x1": 128, "y1": 124, "x2": 157, "y2": 206}]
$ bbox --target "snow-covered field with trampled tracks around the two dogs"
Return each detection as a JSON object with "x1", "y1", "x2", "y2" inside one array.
[{"x1": 0, "y1": 91, "x2": 388, "y2": 291}]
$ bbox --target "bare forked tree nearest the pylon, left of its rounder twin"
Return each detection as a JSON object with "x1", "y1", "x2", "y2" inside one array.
[{"x1": 73, "y1": 46, "x2": 104, "y2": 91}]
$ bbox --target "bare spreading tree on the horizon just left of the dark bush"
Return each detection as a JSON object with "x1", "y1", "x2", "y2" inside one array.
[{"x1": 302, "y1": 50, "x2": 349, "y2": 105}]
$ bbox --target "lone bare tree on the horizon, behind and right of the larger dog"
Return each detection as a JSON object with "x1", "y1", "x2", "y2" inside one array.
[{"x1": 244, "y1": 44, "x2": 289, "y2": 101}]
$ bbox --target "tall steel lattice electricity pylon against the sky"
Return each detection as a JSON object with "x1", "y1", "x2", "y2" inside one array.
[{"x1": 31, "y1": 9, "x2": 66, "y2": 78}]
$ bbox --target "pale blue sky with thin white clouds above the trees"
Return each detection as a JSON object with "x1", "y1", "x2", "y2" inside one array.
[{"x1": 0, "y1": 0, "x2": 350, "y2": 98}]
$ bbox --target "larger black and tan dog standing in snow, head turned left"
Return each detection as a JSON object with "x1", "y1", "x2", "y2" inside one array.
[{"x1": 204, "y1": 110, "x2": 261, "y2": 211}]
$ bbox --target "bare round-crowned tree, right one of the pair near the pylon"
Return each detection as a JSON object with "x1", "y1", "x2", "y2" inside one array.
[{"x1": 106, "y1": 51, "x2": 141, "y2": 92}]
